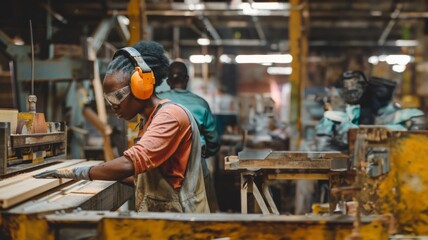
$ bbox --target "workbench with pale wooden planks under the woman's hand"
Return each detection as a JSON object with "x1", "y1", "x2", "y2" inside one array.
[{"x1": 0, "y1": 160, "x2": 134, "y2": 240}]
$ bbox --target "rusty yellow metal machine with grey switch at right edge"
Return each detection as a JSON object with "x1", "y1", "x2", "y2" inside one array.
[{"x1": 349, "y1": 126, "x2": 428, "y2": 236}]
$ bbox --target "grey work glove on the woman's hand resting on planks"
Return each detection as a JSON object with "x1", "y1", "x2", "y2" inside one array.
[{"x1": 34, "y1": 166, "x2": 93, "y2": 180}]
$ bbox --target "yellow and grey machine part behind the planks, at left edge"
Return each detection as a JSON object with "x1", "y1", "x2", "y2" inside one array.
[{"x1": 0, "y1": 110, "x2": 67, "y2": 176}]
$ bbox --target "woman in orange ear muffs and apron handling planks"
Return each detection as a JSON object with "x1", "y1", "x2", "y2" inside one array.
[{"x1": 36, "y1": 41, "x2": 209, "y2": 213}]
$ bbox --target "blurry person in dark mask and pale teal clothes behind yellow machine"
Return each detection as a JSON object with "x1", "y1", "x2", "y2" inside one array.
[{"x1": 317, "y1": 71, "x2": 426, "y2": 151}]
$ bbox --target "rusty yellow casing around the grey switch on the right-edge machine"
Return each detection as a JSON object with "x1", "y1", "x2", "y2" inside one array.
[{"x1": 350, "y1": 128, "x2": 428, "y2": 235}]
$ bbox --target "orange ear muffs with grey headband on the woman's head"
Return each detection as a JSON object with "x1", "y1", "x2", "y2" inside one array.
[{"x1": 113, "y1": 47, "x2": 155, "y2": 100}]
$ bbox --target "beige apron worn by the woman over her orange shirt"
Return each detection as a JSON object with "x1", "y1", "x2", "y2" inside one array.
[{"x1": 135, "y1": 101, "x2": 210, "y2": 213}]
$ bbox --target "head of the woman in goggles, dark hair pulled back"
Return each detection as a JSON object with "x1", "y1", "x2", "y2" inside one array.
[{"x1": 103, "y1": 41, "x2": 169, "y2": 120}]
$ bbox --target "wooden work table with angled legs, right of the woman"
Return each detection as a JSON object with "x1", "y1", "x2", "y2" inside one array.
[{"x1": 224, "y1": 150, "x2": 353, "y2": 214}]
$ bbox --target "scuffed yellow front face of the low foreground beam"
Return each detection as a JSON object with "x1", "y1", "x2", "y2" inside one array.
[{"x1": 99, "y1": 214, "x2": 388, "y2": 240}]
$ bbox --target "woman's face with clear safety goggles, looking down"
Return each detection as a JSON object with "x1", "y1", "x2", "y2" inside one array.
[{"x1": 103, "y1": 72, "x2": 143, "y2": 121}]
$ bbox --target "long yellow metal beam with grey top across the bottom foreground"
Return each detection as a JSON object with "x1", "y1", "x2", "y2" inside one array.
[{"x1": 41, "y1": 211, "x2": 390, "y2": 240}]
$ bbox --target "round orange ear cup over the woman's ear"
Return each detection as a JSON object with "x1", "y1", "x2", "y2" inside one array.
[{"x1": 130, "y1": 67, "x2": 155, "y2": 100}]
